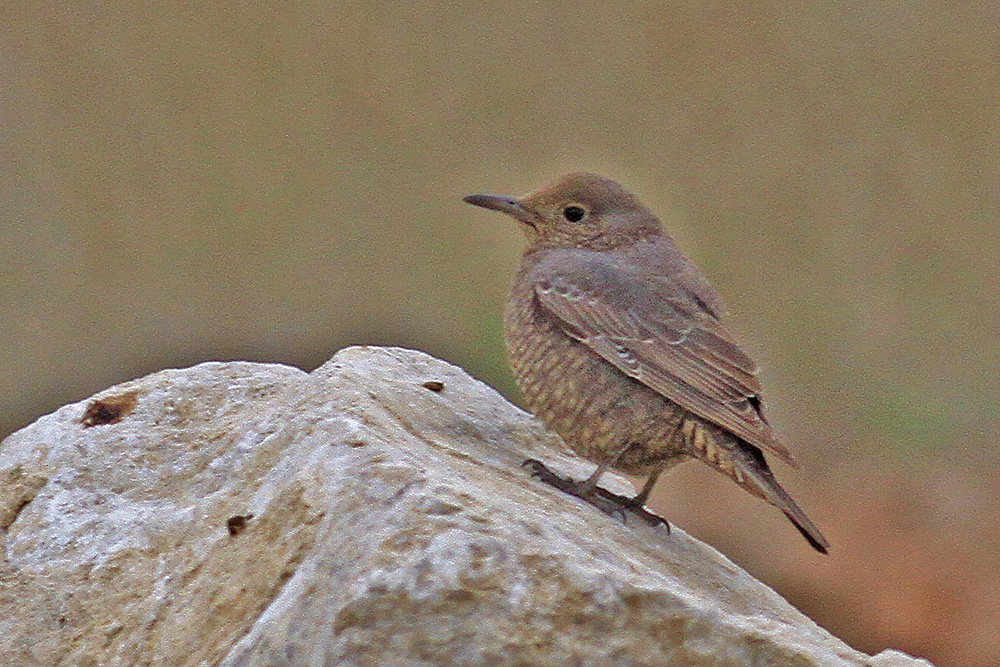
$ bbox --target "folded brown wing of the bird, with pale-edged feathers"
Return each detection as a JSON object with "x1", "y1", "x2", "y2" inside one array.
[{"x1": 532, "y1": 254, "x2": 795, "y2": 466}]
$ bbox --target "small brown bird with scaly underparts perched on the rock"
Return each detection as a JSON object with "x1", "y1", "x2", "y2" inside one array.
[{"x1": 465, "y1": 173, "x2": 828, "y2": 553}]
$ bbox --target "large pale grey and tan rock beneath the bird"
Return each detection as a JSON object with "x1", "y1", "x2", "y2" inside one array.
[{"x1": 0, "y1": 347, "x2": 929, "y2": 667}]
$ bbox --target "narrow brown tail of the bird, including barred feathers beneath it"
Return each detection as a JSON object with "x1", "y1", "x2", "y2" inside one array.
[{"x1": 695, "y1": 429, "x2": 830, "y2": 554}]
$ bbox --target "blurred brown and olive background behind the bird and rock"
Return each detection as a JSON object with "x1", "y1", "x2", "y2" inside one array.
[{"x1": 0, "y1": 0, "x2": 1000, "y2": 667}]
